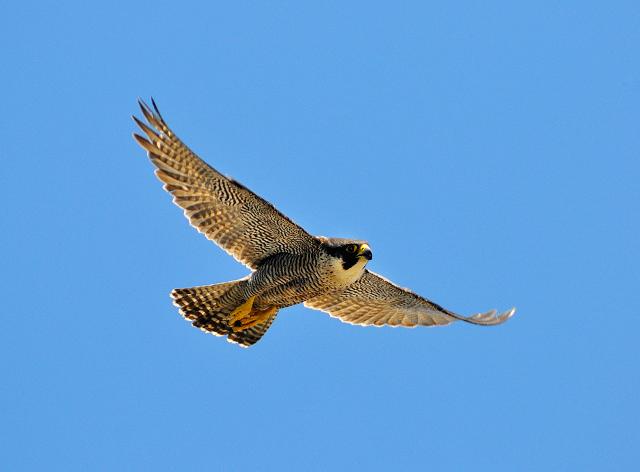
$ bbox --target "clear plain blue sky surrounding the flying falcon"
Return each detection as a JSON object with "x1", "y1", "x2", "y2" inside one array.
[{"x1": 0, "y1": 1, "x2": 640, "y2": 471}]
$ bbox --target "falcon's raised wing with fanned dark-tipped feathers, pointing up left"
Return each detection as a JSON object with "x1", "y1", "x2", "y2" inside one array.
[{"x1": 133, "y1": 100, "x2": 317, "y2": 269}]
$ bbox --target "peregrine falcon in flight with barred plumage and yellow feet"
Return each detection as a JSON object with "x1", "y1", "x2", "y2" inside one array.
[{"x1": 133, "y1": 99, "x2": 515, "y2": 347}]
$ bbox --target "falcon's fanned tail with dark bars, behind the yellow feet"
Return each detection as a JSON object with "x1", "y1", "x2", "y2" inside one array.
[{"x1": 171, "y1": 279, "x2": 277, "y2": 347}]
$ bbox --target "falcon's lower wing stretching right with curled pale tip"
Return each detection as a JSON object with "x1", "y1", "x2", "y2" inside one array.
[{"x1": 304, "y1": 270, "x2": 515, "y2": 327}]
